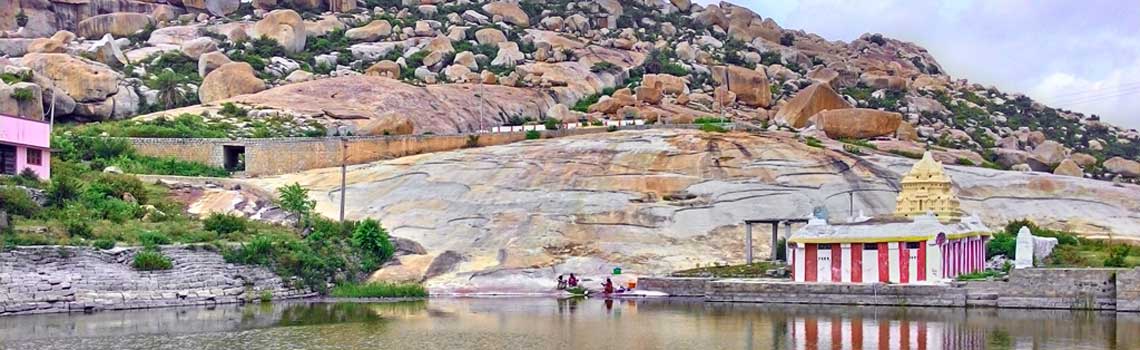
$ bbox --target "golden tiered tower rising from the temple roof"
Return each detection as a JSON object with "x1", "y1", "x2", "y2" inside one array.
[{"x1": 895, "y1": 150, "x2": 962, "y2": 221}]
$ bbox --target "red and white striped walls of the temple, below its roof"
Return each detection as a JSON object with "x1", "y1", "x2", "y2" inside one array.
[{"x1": 788, "y1": 236, "x2": 986, "y2": 283}]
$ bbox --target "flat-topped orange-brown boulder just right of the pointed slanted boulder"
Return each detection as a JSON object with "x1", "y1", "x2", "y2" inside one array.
[{"x1": 813, "y1": 108, "x2": 903, "y2": 139}]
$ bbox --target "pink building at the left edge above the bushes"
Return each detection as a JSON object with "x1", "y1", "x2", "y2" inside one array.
[{"x1": 0, "y1": 114, "x2": 51, "y2": 180}]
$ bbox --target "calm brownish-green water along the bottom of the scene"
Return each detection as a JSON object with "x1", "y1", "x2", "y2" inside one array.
[{"x1": 0, "y1": 299, "x2": 1140, "y2": 350}]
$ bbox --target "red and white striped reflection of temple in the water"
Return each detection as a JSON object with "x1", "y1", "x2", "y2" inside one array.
[{"x1": 788, "y1": 316, "x2": 990, "y2": 350}]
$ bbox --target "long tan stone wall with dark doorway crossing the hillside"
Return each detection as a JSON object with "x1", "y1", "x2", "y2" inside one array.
[{"x1": 128, "y1": 128, "x2": 605, "y2": 177}]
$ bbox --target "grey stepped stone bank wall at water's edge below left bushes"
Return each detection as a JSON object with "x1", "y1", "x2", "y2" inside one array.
[{"x1": 0, "y1": 246, "x2": 314, "y2": 316}]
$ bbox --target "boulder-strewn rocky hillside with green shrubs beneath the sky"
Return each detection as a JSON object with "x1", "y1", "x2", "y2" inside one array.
[{"x1": 0, "y1": 0, "x2": 1140, "y2": 181}]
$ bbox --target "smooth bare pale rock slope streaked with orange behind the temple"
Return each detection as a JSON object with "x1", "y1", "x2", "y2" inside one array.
[{"x1": 249, "y1": 129, "x2": 1140, "y2": 293}]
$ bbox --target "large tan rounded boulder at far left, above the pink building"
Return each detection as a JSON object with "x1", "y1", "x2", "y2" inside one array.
[{"x1": 23, "y1": 54, "x2": 122, "y2": 103}]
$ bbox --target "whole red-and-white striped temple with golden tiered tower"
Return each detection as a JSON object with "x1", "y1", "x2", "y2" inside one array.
[{"x1": 788, "y1": 152, "x2": 990, "y2": 283}]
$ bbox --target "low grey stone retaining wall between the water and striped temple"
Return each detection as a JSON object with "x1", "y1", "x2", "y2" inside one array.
[{"x1": 637, "y1": 268, "x2": 1140, "y2": 311}]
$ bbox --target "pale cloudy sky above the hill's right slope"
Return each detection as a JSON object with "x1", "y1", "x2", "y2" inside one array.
[{"x1": 695, "y1": 0, "x2": 1140, "y2": 129}]
